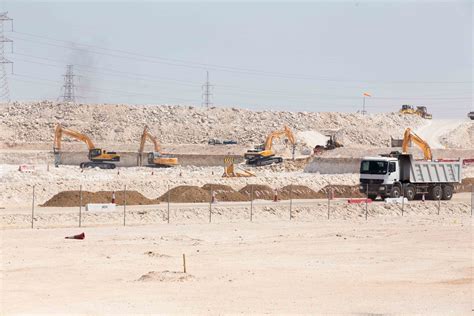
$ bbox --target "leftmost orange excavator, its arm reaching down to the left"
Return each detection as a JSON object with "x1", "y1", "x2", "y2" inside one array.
[{"x1": 53, "y1": 124, "x2": 120, "y2": 169}]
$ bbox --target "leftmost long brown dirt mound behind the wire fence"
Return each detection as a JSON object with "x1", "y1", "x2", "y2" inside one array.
[{"x1": 42, "y1": 191, "x2": 159, "y2": 207}]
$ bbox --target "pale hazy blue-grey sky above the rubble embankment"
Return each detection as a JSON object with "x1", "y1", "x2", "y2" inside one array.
[{"x1": 3, "y1": 1, "x2": 473, "y2": 117}]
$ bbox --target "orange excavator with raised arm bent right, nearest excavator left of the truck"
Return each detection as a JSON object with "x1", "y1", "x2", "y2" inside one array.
[{"x1": 244, "y1": 126, "x2": 296, "y2": 166}]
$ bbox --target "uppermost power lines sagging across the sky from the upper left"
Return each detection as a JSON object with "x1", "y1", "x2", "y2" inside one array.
[{"x1": 9, "y1": 32, "x2": 472, "y2": 84}]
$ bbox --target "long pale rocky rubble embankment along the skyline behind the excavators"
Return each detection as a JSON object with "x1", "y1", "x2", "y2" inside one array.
[{"x1": 0, "y1": 101, "x2": 424, "y2": 147}]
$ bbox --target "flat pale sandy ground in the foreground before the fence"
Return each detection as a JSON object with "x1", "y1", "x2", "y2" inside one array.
[{"x1": 0, "y1": 215, "x2": 473, "y2": 315}]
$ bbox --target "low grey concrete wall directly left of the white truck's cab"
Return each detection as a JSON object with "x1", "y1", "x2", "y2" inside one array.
[{"x1": 304, "y1": 157, "x2": 361, "y2": 174}]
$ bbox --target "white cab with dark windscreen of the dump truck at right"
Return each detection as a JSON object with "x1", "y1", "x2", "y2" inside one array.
[{"x1": 359, "y1": 156, "x2": 400, "y2": 200}]
